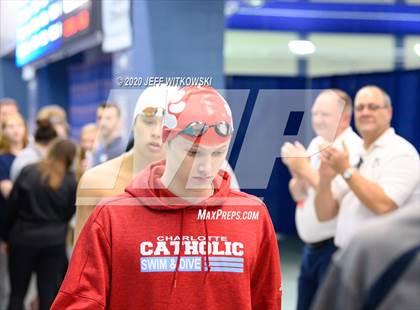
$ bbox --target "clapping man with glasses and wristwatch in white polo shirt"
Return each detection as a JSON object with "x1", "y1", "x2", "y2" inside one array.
[{"x1": 315, "y1": 86, "x2": 420, "y2": 248}]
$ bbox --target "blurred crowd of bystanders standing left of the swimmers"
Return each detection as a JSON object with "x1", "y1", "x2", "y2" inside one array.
[{"x1": 0, "y1": 98, "x2": 126, "y2": 309}]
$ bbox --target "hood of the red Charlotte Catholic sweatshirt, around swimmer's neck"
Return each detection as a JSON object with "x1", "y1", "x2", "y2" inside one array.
[{"x1": 125, "y1": 161, "x2": 230, "y2": 211}]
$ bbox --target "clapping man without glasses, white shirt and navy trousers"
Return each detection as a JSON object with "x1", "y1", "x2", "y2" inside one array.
[{"x1": 281, "y1": 89, "x2": 362, "y2": 310}]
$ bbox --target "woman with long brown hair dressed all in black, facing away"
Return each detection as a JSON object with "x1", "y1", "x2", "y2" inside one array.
[{"x1": 6, "y1": 139, "x2": 77, "y2": 310}]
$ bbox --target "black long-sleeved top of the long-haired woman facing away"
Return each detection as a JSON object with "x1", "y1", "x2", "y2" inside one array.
[{"x1": 6, "y1": 164, "x2": 77, "y2": 246}]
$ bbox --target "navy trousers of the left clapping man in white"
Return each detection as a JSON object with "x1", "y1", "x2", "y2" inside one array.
[{"x1": 297, "y1": 240, "x2": 337, "y2": 310}]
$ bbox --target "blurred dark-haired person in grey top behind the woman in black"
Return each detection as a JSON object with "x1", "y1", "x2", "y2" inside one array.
[{"x1": 10, "y1": 119, "x2": 57, "y2": 182}]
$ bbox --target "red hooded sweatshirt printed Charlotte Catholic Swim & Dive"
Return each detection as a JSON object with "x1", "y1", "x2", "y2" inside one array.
[{"x1": 51, "y1": 162, "x2": 281, "y2": 310}]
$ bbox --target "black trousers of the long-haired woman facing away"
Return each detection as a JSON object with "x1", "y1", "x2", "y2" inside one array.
[{"x1": 8, "y1": 244, "x2": 66, "y2": 310}]
